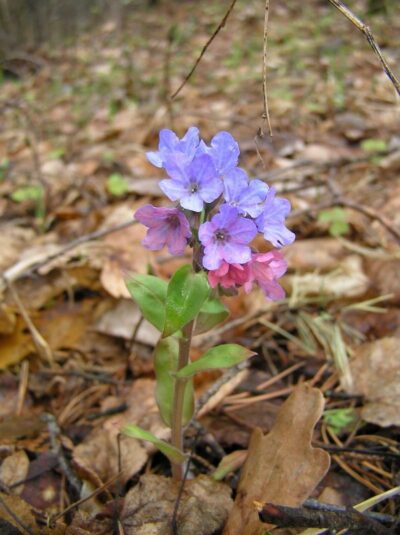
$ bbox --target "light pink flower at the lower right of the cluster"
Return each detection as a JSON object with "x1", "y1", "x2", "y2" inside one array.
[{"x1": 244, "y1": 251, "x2": 287, "y2": 301}]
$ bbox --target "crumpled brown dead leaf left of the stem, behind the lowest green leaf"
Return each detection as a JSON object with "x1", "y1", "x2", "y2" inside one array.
[{"x1": 74, "y1": 379, "x2": 170, "y2": 482}]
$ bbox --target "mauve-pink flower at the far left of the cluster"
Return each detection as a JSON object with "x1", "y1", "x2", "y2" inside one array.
[{"x1": 135, "y1": 204, "x2": 192, "y2": 255}]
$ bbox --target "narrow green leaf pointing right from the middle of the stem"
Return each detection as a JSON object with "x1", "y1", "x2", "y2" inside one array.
[{"x1": 176, "y1": 344, "x2": 255, "y2": 378}]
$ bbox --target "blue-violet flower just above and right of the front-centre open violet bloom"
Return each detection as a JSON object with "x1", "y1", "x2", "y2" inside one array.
[{"x1": 224, "y1": 167, "x2": 268, "y2": 217}]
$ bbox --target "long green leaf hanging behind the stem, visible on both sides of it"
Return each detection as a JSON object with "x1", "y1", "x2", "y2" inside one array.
[{"x1": 154, "y1": 336, "x2": 194, "y2": 427}]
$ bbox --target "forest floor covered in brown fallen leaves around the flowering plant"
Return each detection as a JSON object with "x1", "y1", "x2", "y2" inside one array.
[{"x1": 0, "y1": 0, "x2": 400, "y2": 535}]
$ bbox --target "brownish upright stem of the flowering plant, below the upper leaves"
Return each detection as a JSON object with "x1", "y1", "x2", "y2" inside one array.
[{"x1": 171, "y1": 320, "x2": 194, "y2": 481}]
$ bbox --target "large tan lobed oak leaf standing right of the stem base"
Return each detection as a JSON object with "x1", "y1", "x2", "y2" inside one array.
[{"x1": 224, "y1": 384, "x2": 330, "y2": 535}]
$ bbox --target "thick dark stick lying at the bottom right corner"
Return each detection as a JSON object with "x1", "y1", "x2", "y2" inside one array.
[{"x1": 258, "y1": 503, "x2": 393, "y2": 535}]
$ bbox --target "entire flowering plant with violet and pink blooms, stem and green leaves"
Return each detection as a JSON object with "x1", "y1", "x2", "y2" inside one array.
[{"x1": 122, "y1": 127, "x2": 295, "y2": 479}]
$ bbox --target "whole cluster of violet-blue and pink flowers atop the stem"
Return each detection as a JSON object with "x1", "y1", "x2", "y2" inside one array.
[{"x1": 135, "y1": 127, "x2": 295, "y2": 300}]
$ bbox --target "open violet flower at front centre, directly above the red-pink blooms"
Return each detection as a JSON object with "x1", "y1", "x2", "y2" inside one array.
[{"x1": 199, "y1": 204, "x2": 257, "y2": 270}]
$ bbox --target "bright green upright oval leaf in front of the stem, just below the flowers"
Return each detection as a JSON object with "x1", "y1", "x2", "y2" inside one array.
[{"x1": 163, "y1": 264, "x2": 210, "y2": 337}]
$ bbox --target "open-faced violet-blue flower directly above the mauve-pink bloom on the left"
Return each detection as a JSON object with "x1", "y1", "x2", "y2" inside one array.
[{"x1": 160, "y1": 154, "x2": 223, "y2": 212}]
